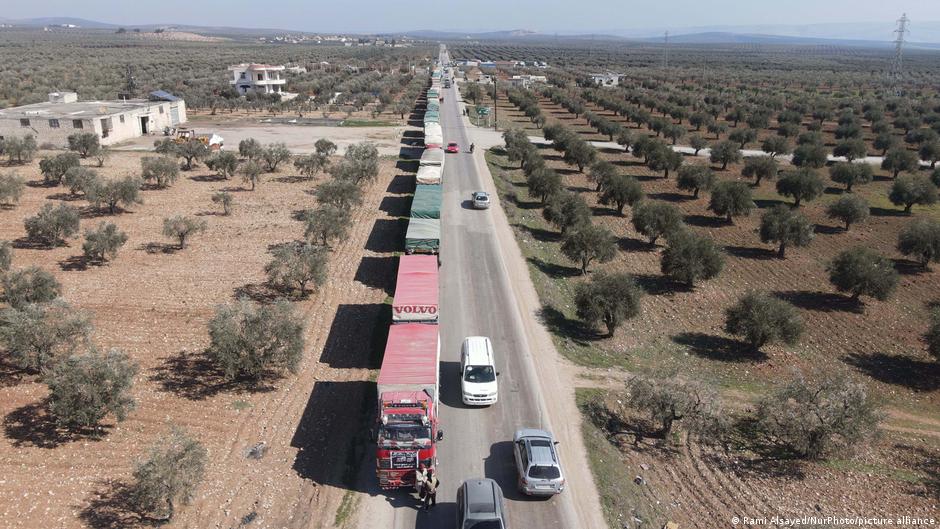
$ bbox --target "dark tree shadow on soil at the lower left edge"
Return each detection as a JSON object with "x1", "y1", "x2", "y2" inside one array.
[{"x1": 3, "y1": 398, "x2": 111, "y2": 448}]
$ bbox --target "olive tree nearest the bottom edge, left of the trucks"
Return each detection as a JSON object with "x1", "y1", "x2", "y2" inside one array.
[{"x1": 129, "y1": 429, "x2": 208, "y2": 520}]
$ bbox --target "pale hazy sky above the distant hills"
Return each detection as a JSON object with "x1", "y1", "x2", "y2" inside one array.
[{"x1": 0, "y1": 0, "x2": 940, "y2": 34}]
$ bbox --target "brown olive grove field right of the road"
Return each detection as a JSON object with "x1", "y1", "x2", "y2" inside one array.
[{"x1": 454, "y1": 45, "x2": 940, "y2": 527}]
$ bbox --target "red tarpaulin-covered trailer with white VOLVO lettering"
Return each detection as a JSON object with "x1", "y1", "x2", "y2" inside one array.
[{"x1": 392, "y1": 255, "x2": 438, "y2": 323}]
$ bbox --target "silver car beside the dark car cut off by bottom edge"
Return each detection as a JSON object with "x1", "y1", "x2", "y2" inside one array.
[{"x1": 512, "y1": 428, "x2": 565, "y2": 496}]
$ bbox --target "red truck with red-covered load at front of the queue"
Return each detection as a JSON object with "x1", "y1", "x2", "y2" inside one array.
[{"x1": 373, "y1": 323, "x2": 444, "y2": 489}]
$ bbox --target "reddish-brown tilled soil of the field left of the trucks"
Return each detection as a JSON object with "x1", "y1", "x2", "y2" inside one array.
[{"x1": 0, "y1": 152, "x2": 408, "y2": 528}]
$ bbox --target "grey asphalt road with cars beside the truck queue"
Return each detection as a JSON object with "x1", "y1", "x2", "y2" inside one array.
[{"x1": 352, "y1": 46, "x2": 603, "y2": 529}]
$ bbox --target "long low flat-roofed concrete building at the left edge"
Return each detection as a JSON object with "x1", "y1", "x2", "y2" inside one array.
[{"x1": 0, "y1": 91, "x2": 186, "y2": 146}]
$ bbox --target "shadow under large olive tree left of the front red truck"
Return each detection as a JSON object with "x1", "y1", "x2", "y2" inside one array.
[{"x1": 148, "y1": 350, "x2": 282, "y2": 400}]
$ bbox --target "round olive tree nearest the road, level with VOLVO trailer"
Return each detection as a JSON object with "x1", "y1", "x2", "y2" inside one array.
[{"x1": 574, "y1": 273, "x2": 643, "y2": 336}]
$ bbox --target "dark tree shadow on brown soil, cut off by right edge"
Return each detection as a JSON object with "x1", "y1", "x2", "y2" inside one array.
[{"x1": 845, "y1": 353, "x2": 940, "y2": 392}]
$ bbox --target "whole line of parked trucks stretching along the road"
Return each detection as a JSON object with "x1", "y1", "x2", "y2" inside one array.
[{"x1": 374, "y1": 67, "x2": 444, "y2": 489}]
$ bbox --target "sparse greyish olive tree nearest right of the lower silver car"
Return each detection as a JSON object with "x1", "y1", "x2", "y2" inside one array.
[{"x1": 627, "y1": 376, "x2": 723, "y2": 439}]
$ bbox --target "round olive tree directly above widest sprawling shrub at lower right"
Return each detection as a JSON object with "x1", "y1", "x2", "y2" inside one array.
[{"x1": 725, "y1": 292, "x2": 803, "y2": 350}]
